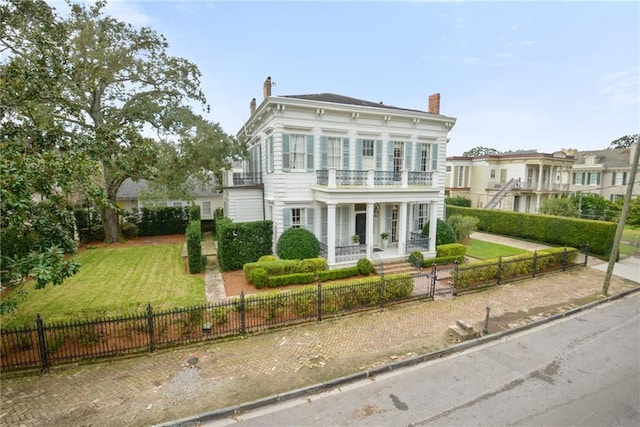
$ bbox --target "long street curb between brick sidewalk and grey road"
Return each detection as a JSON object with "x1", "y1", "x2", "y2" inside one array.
[{"x1": 156, "y1": 286, "x2": 640, "y2": 427}]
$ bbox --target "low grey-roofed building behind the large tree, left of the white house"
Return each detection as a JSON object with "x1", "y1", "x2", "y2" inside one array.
[{"x1": 116, "y1": 179, "x2": 222, "y2": 220}]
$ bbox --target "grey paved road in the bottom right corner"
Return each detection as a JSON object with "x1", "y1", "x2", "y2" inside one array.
[{"x1": 207, "y1": 294, "x2": 640, "y2": 426}]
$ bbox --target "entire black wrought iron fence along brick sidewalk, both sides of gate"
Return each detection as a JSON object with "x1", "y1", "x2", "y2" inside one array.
[{"x1": 0, "y1": 247, "x2": 589, "y2": 371}]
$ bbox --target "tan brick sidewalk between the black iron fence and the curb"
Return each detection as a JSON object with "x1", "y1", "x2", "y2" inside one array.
[{"x1": 0, "y1": 268, "x2": 637, "y2": 426}]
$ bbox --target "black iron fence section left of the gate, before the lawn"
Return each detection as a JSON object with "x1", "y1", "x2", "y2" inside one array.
[{"x1": 0, "y1": 276, "x2": 429, "y2": 371}]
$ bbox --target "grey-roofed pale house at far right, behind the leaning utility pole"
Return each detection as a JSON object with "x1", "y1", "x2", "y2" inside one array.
[{"x1": 571, "y1": 143, "x2": 640, "y2": 202}]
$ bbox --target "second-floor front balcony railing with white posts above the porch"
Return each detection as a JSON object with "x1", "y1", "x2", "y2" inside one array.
[{"x1": 316, "y1": 169, "x2": 433, "y2": 188}]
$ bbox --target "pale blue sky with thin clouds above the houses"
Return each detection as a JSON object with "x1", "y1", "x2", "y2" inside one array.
[{"x1": 49, "y1": 0, "x2": 640, "y2": 156}]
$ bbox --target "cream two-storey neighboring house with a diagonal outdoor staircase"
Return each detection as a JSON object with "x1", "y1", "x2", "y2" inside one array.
[{"x1": 446, "y1": 151, "x2": 575, "y2": 213}]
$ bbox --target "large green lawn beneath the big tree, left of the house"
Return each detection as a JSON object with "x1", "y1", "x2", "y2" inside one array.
[{"x1": 0, "y1": 244, "x2": 206, "y2": 328}]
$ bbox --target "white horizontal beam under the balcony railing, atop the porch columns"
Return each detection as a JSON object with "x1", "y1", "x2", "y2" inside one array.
[{"x1": 311, "y1": 187, "x2": 444, "y2": 203}]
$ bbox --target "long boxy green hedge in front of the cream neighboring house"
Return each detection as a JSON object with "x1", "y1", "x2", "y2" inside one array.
[{"x1": 447, "y1": 205, "x2": 617, "y2": 258}]
